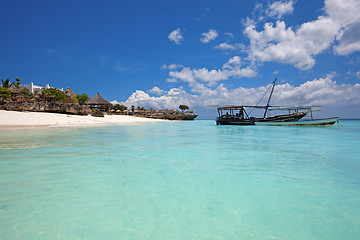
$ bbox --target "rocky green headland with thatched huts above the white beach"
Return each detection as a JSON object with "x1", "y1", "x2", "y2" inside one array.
[{"x1": 0, "y1": 78, "x2": 197, "y2": 120}]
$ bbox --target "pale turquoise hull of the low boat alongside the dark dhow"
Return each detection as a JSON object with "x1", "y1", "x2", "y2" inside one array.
[{"x1": 255, "y1": 117, "x2": 339, "y2": 126}]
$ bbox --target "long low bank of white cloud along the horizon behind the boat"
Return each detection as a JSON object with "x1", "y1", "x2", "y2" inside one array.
[{"x1": 123, "y1": 75, "x2": 360, "y2": 117}]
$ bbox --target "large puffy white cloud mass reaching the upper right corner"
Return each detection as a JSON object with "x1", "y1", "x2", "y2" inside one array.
[{"x1": 244, "y1": 0, "x2": 360, "y2": 70}]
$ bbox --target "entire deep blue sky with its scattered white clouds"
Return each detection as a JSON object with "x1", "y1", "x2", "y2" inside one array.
[{"x1": 0, "y1": 0, "x2": 360, "y2": 119}]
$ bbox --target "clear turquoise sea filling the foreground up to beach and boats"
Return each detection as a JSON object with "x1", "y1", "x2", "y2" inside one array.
[{"x1": 0, "y1": 120, "x2": 360, "y2": 240}]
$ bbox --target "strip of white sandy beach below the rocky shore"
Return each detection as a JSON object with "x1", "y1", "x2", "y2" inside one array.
[{"x1": 0, "y1": 110, "x2": 168, "y2": 130}]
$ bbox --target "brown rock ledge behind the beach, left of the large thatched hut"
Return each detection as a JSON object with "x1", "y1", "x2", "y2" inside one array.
[{"x1": 0, "y1": 102, "x2": 91, "y2": 115}]
